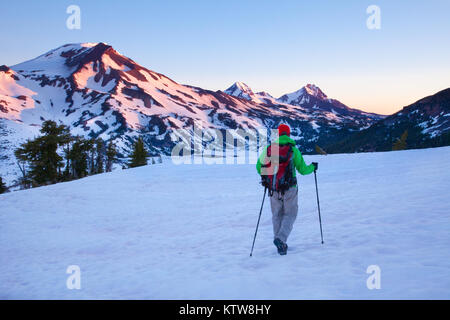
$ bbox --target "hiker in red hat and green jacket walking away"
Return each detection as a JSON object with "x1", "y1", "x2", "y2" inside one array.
[{"x1": 256, "y1": 124, "x2": 318, "y2": 255}]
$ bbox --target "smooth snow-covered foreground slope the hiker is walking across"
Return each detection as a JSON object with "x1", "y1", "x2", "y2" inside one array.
[{"x1": 0, "y1": 147, "x2": 450, "y2": 299}]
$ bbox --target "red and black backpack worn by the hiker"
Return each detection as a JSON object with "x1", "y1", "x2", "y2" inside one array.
[{"x1": 261, "y1": 143, "x2": 297, "y2": 196}]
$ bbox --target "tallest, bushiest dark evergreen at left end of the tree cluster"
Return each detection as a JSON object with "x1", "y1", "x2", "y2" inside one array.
[{"x1": 14, "y1": 120, "x2": 70, "y2": 186}]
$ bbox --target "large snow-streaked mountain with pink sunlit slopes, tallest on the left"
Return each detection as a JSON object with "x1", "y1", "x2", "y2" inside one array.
[{"x1": 0, "y1": 43, "x2": 381, "y2": 185}]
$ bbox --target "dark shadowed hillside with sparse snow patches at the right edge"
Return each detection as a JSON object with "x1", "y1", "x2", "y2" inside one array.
[{"x1": 326, "y1": 88, "x2": 450, "y2": 152}]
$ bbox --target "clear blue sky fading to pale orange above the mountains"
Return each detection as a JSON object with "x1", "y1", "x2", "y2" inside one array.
[{"x1": 0, "y1": 0, "x2": 450, "y2": 114}]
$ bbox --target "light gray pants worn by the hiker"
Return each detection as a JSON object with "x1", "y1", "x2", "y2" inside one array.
[{"x1": 270, "y1": 187, "x2": 298, "y2": 242}]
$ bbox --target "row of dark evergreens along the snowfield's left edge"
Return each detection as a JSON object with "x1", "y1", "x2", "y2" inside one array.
[{"x1": 0, "y1": 120, "x2": 154, "y2": 193}]
